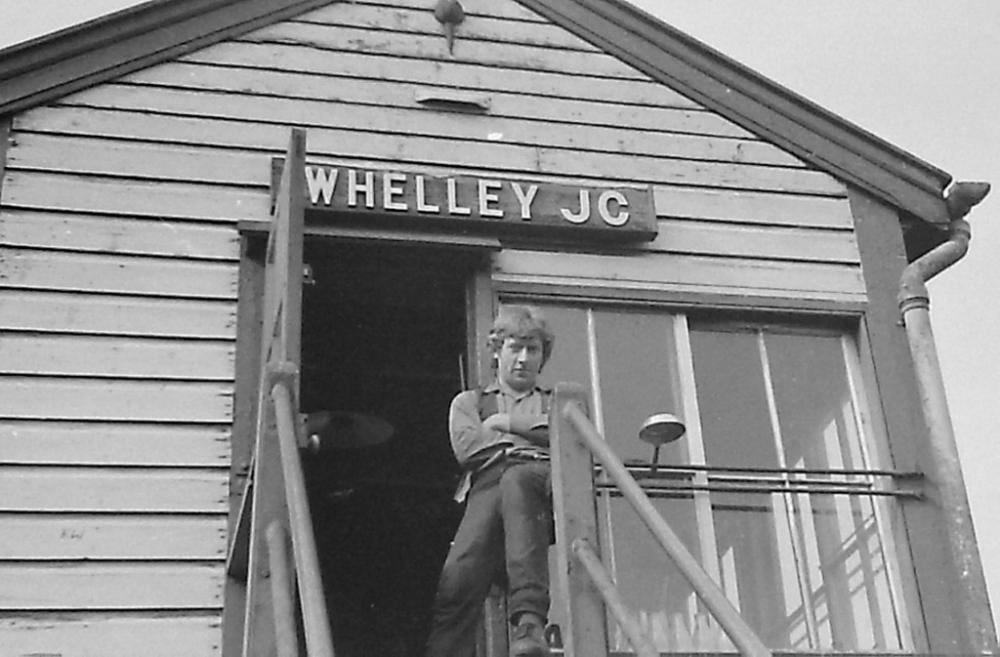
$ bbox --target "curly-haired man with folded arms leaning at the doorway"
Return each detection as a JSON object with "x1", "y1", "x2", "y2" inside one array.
[{"x1": 427, "y1": 306, "x2": 554, "y2": 657}]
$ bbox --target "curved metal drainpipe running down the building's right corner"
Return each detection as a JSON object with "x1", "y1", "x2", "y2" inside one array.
[{"x1": 898, "y1": 182, "x2": 997, "y2": 655}]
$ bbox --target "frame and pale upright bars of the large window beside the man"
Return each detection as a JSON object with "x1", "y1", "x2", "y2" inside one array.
[{"x1": 508, "y1": 294, "x2": 921, "y2": 655}]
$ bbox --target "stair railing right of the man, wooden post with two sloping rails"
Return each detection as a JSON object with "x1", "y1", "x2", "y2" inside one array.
[{"x1": 550, "y1": 383, "x2": 772, "y2": 657}]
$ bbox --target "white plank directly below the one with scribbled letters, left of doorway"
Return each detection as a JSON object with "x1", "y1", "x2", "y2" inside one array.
[{"x1": 0, "y1": 564, "x2": 225, "y2": 611}]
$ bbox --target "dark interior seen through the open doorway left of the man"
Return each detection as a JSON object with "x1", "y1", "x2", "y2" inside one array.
[{"x1": 301, "y1": 240, "x2": 475, "y2": 657}]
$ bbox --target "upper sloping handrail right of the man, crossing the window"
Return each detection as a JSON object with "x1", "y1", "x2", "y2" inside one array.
[{"x1": 561, "y1": 403, "x2": 772, "y2": 657}]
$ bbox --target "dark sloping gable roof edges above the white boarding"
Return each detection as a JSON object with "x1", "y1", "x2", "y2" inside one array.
[{"x1": 0, "y1": 0, "x2": 951, "y2": 224}]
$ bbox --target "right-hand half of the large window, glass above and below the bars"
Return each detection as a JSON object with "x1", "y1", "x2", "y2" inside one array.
[{"x1": 691, "y1": 327, "x2": 902, "y2": 650}]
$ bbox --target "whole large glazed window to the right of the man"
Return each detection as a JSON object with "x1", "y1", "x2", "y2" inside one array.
[{"x1": 545, "y1": 305, "x2": 911, "y2": 652}]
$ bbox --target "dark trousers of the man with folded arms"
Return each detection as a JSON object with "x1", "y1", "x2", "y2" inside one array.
[{"x1": 427, "y1": 459, "x2": 552, "y2": 657}]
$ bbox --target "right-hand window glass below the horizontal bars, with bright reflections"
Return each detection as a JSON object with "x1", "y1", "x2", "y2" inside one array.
[{"x1": 712, "y1": 486, "x2": 902, "y2": 651}]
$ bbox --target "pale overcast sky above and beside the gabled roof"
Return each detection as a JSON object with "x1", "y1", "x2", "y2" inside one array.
[{"x1": 0, "y1": 0, "x2": 1000, "y2": 628}]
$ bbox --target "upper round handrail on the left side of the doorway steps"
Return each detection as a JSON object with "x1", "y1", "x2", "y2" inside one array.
[{"x1": 271, "y1": 377, "x2": 333, "y2": 657}]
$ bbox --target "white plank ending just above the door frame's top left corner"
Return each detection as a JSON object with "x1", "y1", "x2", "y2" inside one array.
[{"x1": 0, "y1": 171, "x2": 268, "y2": 222}]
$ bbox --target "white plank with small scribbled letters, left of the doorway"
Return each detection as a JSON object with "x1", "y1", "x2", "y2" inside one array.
[{"x1": 0, "y1": 514, "x2": 226, "y2": 561}]
